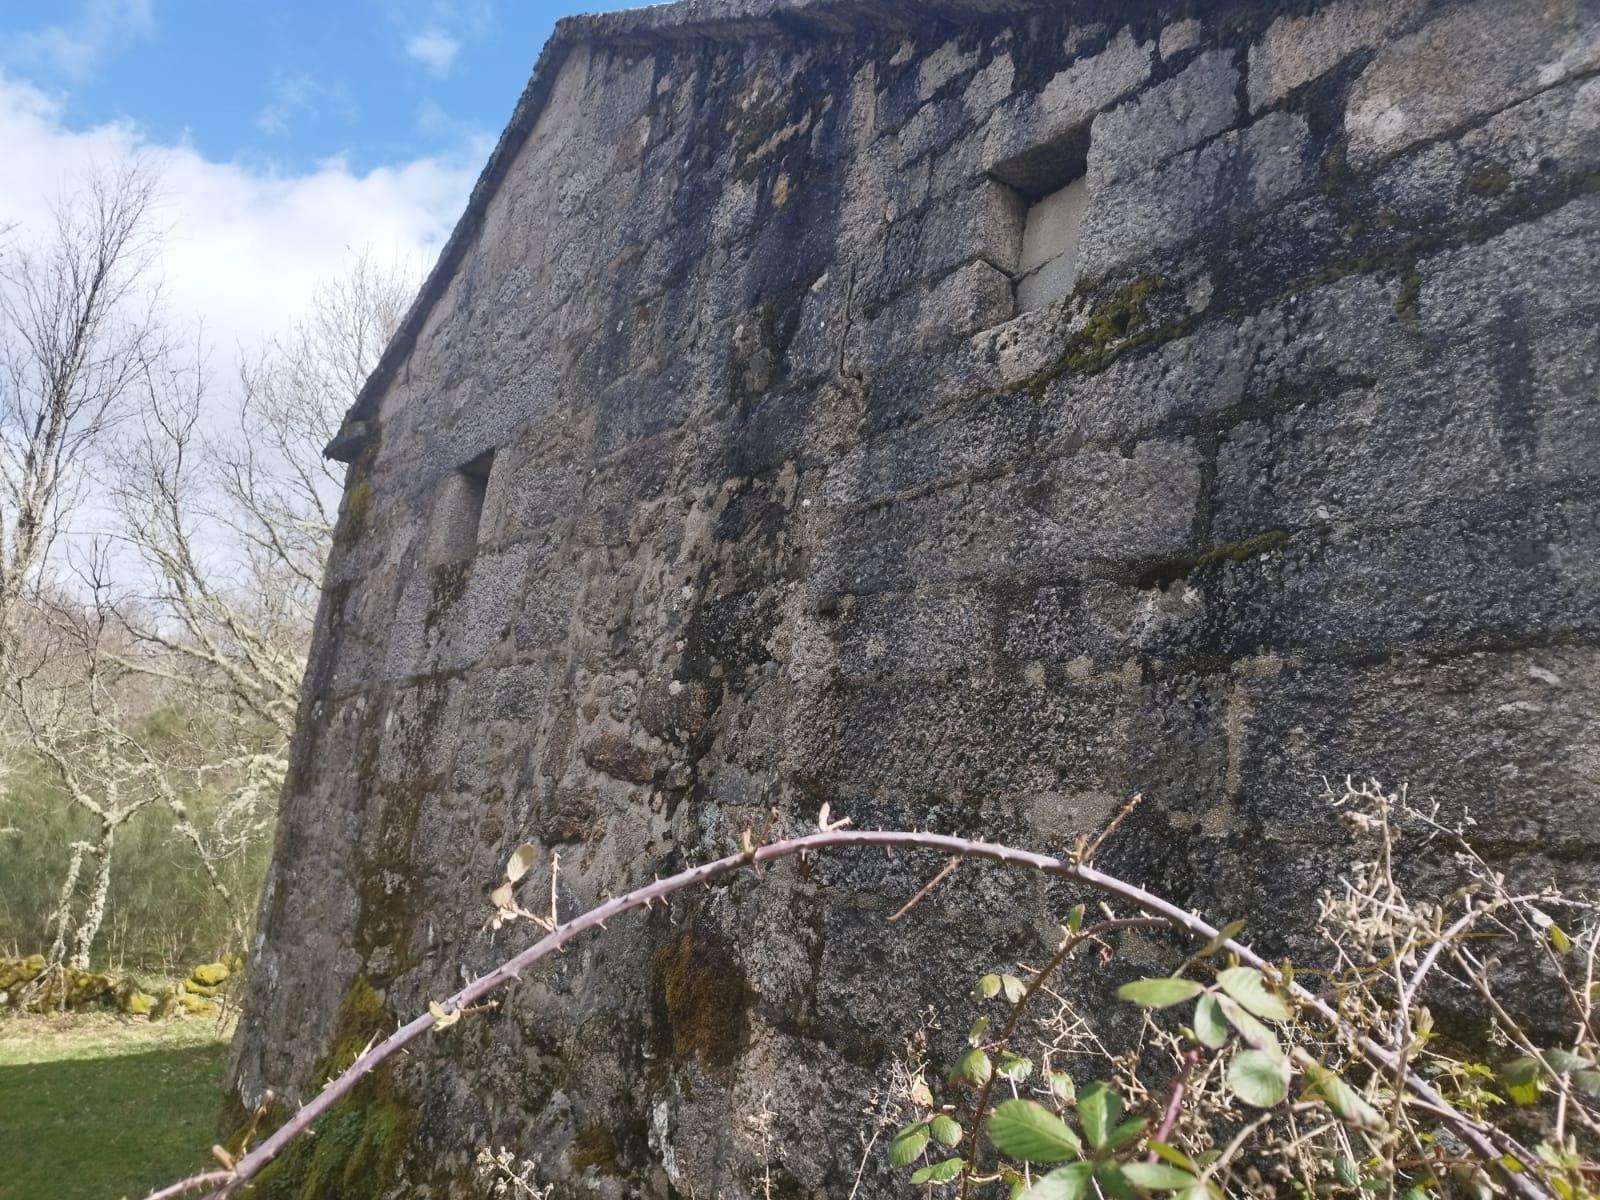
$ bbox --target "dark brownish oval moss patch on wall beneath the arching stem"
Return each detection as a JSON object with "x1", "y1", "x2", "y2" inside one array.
[{"x1": 650, "y1": 926, "x2": 750, "y2": 1069}]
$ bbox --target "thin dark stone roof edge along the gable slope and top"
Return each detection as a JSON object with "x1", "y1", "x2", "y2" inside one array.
[{"x1": 323, "y1": 0, "x2": 1074, "y2": 462}]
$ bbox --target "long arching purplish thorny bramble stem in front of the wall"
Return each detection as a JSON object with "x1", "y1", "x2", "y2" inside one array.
[{"x1": 150, "y1": 829, "x2": 1549, "y2": 1200}]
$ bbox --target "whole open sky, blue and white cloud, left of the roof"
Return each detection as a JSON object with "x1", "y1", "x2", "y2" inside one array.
[{"x1": 0, "y1": 0, "x2": 627, "y2": 376}]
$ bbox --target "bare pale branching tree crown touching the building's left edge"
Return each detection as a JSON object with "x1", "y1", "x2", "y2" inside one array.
[{"x1": 114, "y1": 258, "x2": 411, "y2": 923}]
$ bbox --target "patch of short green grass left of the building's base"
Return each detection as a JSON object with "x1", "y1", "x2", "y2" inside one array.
[{"x1": 0, "y1": 1014, "x2": 230, "y2": 1200}]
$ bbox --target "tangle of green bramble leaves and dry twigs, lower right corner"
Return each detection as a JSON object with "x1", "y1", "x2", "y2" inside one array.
[{"x1": 886, "y1": 786, "x2": 1600, "y2": 1200}]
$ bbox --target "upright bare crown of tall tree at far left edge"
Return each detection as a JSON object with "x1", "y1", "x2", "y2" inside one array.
[{"x1": 0, "y1": 165, "x2": 165, "y2": 656}]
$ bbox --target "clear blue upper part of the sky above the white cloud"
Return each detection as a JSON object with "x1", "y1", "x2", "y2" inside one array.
[{"x1": 0, "y1": 0, "x2": 624, "y2": 171}]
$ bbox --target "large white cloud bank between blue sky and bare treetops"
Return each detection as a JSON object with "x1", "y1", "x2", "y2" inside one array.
[{"x1": 0, "y1": 75, "x2": 476, "y2": 382}]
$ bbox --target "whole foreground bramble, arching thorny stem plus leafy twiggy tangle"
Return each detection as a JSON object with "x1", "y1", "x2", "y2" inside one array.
[{"x1": 150, "y1": 786, "x2": 1600, "y2": 1200}]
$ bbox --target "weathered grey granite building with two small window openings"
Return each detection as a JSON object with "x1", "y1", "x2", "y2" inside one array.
[{"x1": 232, "y1": 0, "x2": 1600, "y2": 1197}]
